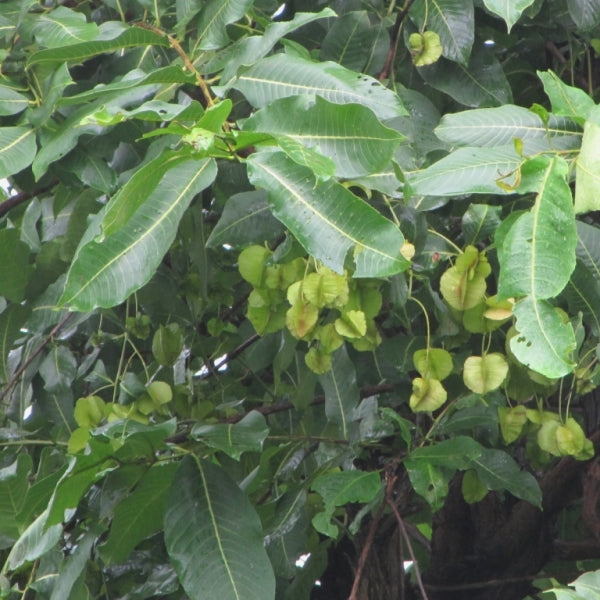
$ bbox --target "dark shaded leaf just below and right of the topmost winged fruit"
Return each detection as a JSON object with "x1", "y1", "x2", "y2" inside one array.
[{"x1": 413, "y1": 51, "x2": 512, "y2": 107}]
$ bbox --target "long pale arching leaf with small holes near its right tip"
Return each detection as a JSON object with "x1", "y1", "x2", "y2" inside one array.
[{"x1": 233, "y1": 54, "x2": 407, "y2": 119}]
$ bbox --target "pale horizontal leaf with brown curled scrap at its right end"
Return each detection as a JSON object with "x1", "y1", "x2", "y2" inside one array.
[{"x1": 405, "y1": 144, "x2": 524, "y2": 196}]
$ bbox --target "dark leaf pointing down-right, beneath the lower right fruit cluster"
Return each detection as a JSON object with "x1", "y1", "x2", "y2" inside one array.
[{"x1": 471, "y1": 448, "x2": 542, "y2": 508}]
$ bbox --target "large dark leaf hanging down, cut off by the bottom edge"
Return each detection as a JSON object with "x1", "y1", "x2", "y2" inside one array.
[{"x1": 164, "y1": 457, "x2": 275, "y2": 600}]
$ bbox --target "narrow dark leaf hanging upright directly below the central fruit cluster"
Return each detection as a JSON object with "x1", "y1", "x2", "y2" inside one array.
[{"x1": 319, "y1": 346, "x2": 360, "y2": 440}]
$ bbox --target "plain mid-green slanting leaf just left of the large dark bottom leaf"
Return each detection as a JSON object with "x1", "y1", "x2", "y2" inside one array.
[{"x1": 100, "y1": 463, "x2": 178, "y2": 564}]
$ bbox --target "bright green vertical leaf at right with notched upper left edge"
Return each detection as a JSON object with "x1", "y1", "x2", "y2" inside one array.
[{"x1": 498, "y1": 156, "x2": 577, "y2": 299}]
